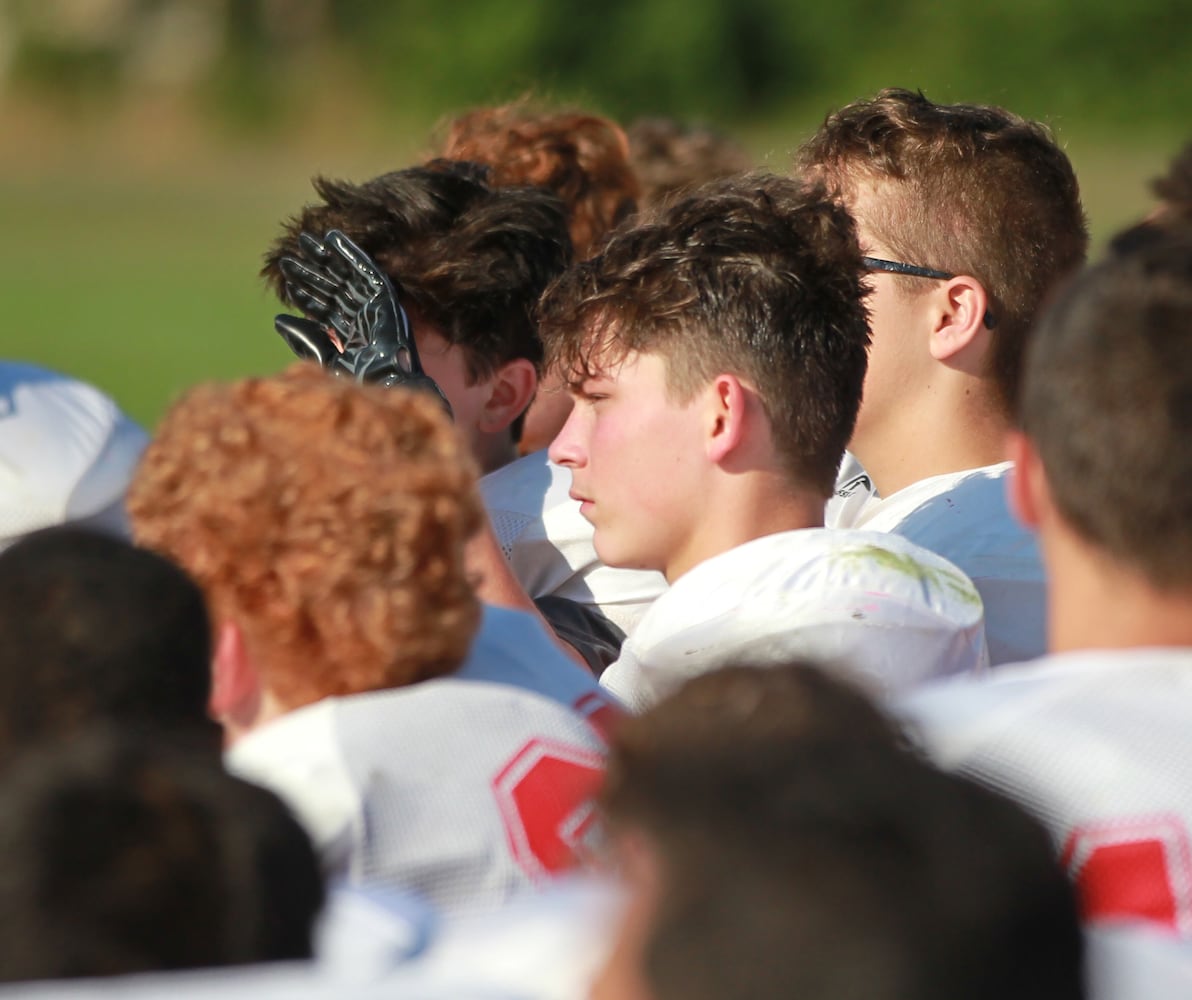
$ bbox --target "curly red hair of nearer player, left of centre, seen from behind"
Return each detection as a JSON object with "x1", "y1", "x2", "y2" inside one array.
[{"x1": 128, "y1": 362, "x2": 482, "y2": 708}]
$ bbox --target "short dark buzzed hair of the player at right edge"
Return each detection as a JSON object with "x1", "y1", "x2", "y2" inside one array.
[{"x1": 1022, "y1": 224, "x2": 1192, "y2": 589}]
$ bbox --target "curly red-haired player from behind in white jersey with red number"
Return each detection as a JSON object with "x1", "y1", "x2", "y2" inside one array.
[{"x1": 129, "y1": 365, "x2": 602, "y2": 908}]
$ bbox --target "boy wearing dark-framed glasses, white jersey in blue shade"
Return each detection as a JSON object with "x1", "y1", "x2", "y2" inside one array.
[{"x1": 795, "y1": 89, "x2": 1088, "y2": 665}]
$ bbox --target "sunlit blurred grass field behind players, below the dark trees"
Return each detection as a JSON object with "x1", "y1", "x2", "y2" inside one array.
[{"x1": 0, "y1": 112, "x2": 1184, "y2": 426}]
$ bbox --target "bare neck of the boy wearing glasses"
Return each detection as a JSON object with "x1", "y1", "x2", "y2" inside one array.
[{"x1": 849, "y1": 373, "x2": 1010, "y2": 497}]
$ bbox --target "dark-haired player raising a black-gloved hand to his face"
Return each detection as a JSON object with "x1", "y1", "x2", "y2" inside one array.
[{"x1": 262, "y1": 161, "x2": 664, "y2": 672}]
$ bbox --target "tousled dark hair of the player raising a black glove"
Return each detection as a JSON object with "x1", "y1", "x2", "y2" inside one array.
[{"x1": 261, "y1": 161, "x2": 571, "y2": 381}]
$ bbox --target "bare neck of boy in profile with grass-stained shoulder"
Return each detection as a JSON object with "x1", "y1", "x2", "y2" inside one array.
[{"x1": 663, "y1": 471, "x2": 824, "y2": 583}]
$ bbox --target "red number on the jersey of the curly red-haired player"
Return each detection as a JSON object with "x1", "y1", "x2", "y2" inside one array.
[{"x1": 492, "y1": 739, "x2": 604, "y2": 880}]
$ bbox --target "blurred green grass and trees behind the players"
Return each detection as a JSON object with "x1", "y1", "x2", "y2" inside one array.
[{"x1": 0, "y1": 0, "x2": 1192, "y2": 426}]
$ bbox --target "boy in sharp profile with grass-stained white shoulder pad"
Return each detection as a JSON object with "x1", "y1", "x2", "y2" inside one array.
[{"x1": 540, "y1": 175, "x2": 986, "y2": 708}]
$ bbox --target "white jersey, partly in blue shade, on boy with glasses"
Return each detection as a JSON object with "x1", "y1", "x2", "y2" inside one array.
[{"x1": 825, "y1": 461, "x2": 1047, "y2": 666}]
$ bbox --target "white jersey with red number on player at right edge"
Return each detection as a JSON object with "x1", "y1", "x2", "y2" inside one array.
[{"x1": 896, "y1": 648, "x2": 1192, "y2": 938}]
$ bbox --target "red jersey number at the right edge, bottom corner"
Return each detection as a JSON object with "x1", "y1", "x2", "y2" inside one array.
[{"x1": 1062, "y1": 815, "x2": 1192, "y2": 934}]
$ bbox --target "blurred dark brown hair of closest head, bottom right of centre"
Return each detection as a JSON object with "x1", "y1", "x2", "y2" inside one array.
[{"x1": 602, "y1": 663, "x2": 1081, "y2": 1000}]
